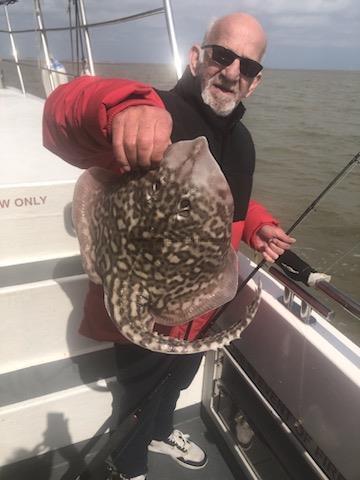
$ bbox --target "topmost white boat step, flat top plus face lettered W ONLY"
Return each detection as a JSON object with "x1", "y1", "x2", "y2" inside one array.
[{"x1": 0, "y1": 88, "x2": 81, "y2": 266}]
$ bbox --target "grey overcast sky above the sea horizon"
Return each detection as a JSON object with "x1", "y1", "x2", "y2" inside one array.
[{"x1": 0, "y1": 0, "x2": 360, "y2": 70}]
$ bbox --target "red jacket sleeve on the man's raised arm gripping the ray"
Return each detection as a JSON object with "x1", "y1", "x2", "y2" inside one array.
[{"x1": 43, "y1": 76, "x2": 164, "y2": 168}]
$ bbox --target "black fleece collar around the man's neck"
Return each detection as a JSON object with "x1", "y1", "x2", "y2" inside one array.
[{"x1": 172, "y1": 66, "x2": 246, "y2": 132}]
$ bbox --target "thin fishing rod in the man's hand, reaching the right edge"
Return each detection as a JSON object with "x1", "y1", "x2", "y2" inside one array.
[{"x1": 199, "y1": 152, "x2": 360, "y2": 337}]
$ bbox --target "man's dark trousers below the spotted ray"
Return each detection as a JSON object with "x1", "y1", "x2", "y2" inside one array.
[{"x1": 112, "y1": 344, "x2": 202, "y2": 477}]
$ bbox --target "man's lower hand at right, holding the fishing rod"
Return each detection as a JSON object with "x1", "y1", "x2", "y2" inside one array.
[{"x1": 253, "y1": 225, "x2": 296, "y2": 263}]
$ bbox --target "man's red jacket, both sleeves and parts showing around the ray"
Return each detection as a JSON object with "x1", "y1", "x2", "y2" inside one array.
[{"x1": 43, "y1": 76, "x2": 278, "y2": 343}]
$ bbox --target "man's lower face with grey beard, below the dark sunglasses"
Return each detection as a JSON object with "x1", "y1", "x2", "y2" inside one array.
[{"x1": 198, "y1": 48, "x2": 261, "y2": 117}]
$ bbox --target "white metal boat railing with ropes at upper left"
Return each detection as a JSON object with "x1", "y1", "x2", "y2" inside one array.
[{"x1": 0, "y1": 0, "x2": 182, "y2": 95}]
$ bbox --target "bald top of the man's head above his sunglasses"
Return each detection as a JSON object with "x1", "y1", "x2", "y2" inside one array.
[{"x1": 204, "y1": 12, "x2": 266, "y2": 60}]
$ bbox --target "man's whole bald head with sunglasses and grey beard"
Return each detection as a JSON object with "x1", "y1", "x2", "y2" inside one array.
[{"x1": 189, "y1": 13, "x2": 266, "y2": 117}]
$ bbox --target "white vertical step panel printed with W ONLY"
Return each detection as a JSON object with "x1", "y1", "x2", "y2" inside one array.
[{"x1": 0, "y1": 181, "x2": 79, "y2": 266}]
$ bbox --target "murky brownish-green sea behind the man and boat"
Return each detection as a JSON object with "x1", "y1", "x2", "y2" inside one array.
[{"x1": 0, "y1": 61, "x2": 360, "y2": 345}]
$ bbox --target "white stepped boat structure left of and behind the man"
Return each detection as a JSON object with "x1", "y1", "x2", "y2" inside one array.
[{"x1": 0, "y1": 89, "x2": 208, "y2": 480}]
